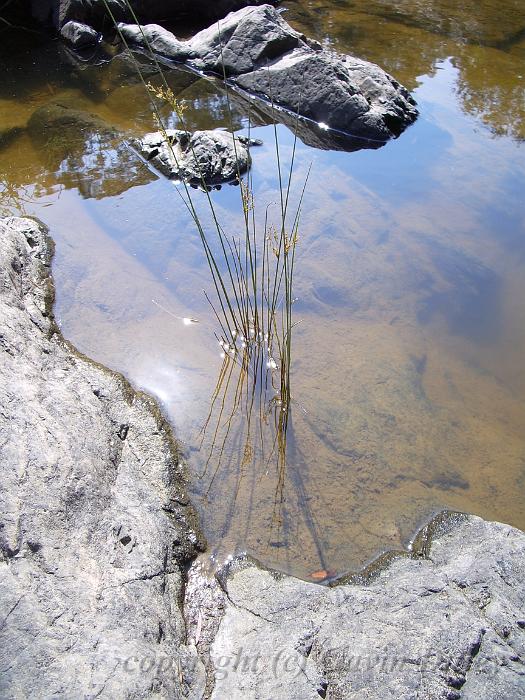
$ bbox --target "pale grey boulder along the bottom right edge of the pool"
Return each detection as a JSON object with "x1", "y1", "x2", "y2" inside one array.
[{"x1": 186, "y1": 516, "x2": 525, "y2": 700}]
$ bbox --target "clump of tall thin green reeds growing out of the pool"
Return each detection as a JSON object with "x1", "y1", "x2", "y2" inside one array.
[{"x1": 103, "y1": 0, "x2": 310, "y2": 481}]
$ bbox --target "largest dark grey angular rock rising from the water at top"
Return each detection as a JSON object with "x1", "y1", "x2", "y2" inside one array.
[{"x1": 120, "y1": 5, "x2": 418, "y2": 150}]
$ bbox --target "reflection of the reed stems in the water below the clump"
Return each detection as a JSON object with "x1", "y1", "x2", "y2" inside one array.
[{"x1": 198, "y1": 345, "x2": 293, "y2": 556}]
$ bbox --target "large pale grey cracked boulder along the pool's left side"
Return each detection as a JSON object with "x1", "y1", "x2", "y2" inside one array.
[{"x1": 0, "y1": 218, "x2": 203, "y2": 698}]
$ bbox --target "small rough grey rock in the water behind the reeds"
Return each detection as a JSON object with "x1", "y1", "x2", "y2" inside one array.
[{"x1": 133, "y1": 129, "x2": 257, "y2": 187}]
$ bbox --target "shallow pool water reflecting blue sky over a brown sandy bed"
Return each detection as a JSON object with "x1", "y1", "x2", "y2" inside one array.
[{"x1": 0, "y1": 0, "x2": 525, "y2": 578}]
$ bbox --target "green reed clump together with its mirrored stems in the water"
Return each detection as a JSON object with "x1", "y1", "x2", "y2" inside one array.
[{"x1": 104, "y1": 0, "x2": 309, "y2": 524}]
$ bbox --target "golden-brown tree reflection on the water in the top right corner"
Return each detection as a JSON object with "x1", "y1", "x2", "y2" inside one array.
[{"x1": 287, "y1": 0, "x2": 525, "y2": 139}]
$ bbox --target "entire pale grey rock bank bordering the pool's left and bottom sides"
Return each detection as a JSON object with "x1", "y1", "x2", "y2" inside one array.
[{"x1": 0, "y1": 218, "x2": 525, "y2": 700}]
